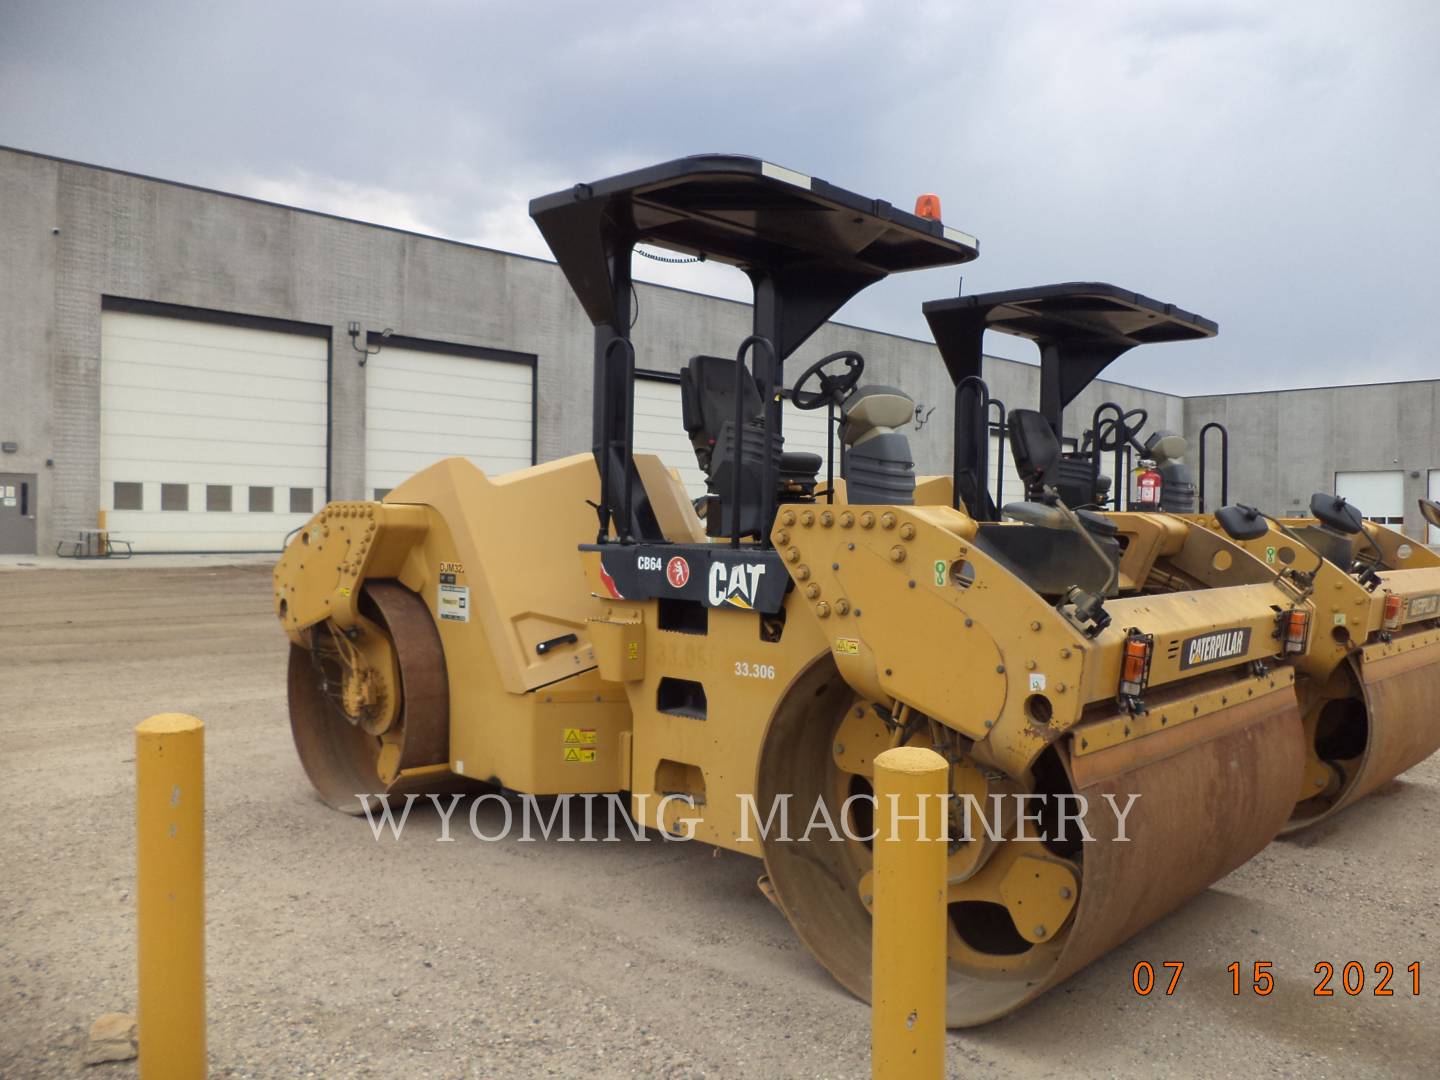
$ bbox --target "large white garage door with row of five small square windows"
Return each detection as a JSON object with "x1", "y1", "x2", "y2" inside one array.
[{"x1": 99, "y1": 311, "x2": 330, "y2": 552}]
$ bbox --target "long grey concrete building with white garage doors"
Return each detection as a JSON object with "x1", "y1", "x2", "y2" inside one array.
[{"x1": 0, "y1": 148, "x2": 1440, "y2": 553}]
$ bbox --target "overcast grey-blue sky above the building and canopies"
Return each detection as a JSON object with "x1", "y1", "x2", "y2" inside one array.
[{"x1": 0, "y1": 0, "x2": 1440, "y2": 393}]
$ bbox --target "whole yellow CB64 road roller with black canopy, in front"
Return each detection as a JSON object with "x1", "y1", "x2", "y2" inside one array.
[{"x1": 275, "y1": 156, "x2": 1315, "y2": 1025}]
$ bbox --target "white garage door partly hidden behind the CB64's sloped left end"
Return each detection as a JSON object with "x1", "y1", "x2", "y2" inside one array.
[{"x1": 364, "y1": 344, "x2": 534, "y2": 498}]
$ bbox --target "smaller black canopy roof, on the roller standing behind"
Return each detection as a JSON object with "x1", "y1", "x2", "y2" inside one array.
[{"x1": 923, "y1": 281, "x2": 1220, "y2": 433}]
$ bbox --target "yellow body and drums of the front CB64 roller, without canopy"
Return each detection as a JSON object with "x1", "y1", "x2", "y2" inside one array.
[{"x1": 275, "y1": 455, "x2": 1324, "y2": 1024}]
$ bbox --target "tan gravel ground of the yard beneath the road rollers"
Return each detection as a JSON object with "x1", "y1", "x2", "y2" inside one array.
[{"x1": 0, "y1": 560, "x2": 1440, "y2": 1080}]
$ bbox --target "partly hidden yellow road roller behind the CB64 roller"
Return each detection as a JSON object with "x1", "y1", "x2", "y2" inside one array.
[{"x1": 924, "y1": 292, "x2": 1440, "y2": 831}]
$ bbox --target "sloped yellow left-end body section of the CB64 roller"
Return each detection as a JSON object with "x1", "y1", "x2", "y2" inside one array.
[{"x1": 275, "y1": 454, "x2": 629, "y2": 811}]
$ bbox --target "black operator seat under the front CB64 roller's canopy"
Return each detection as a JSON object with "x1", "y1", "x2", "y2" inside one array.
[{"x1": 680, "y1": 356, "x2": 822, "y2": 536}]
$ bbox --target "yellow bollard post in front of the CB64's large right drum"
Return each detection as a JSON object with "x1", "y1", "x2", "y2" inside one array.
[{"x1": 870, "y1": 746, "x2": 949, "y2": 1080}]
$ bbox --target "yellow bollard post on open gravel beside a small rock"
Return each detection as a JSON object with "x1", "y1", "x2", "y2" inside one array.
[{"x1": 135, "y1": 713, "x2": 206, "y2": 1080}]
